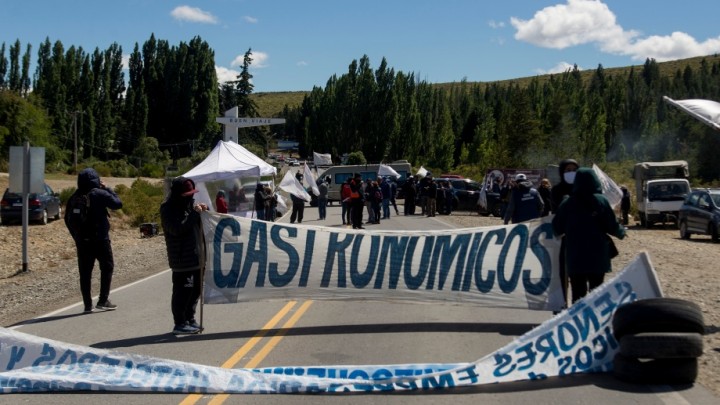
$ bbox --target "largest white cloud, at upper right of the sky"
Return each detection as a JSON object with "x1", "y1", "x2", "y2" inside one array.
[{"x1": 510, "y1": 0, "x2": 720, "y2": 61}]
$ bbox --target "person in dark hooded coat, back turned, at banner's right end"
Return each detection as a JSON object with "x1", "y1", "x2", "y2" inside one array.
[{"x1": 552, "y1": 168, "x2": 625, "y2": 303}]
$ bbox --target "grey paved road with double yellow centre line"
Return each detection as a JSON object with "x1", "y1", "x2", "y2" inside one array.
[{"x1": 0, "y1": 206, "x2": 720, "y2": 405}]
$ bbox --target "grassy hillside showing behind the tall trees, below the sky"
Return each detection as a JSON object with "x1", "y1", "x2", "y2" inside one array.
[{"x1": 251, "y1": 54, "x2": 720, "y2": 117}]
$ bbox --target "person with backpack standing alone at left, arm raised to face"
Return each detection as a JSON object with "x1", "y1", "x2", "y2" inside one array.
[{"x1": 65, "y1": 168, "x2": 122, "y2": 313}]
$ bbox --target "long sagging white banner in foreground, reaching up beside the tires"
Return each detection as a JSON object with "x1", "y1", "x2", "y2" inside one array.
[{"x1": 0, "y1": 253, "x2": 662, "y2": 394}]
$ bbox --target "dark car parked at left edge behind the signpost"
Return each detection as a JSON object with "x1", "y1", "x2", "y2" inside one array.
[{"x1": 0, "y1": 184, "x2": 62, "y2": 225}]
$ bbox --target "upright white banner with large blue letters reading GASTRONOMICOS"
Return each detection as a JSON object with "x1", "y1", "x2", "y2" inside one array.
[{"x1": 202, "y1": 211, "x2": 563, "y2": 310}]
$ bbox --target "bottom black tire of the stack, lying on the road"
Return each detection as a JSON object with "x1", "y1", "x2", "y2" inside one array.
[{"x1": 613, "y1": 353, "x2": 698, "y2": 384}]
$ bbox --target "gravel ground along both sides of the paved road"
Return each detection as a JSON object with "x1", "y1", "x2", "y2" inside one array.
[{"x1": 0, "y1": 174, "x2": 720, "y2": 396}]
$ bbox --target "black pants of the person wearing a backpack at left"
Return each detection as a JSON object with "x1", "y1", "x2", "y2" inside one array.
[{"x1": 75, "y1": 239, "x2": 115, "y2": 309}]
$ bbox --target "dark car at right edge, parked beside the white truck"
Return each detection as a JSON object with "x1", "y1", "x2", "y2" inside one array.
[{"x1": 678, "y1": 189, "x2": 720, "y2": 242}]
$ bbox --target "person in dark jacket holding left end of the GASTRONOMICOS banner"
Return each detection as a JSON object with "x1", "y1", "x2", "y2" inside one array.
[{"x1": 160, "y1": 176, "x2": 208, "y2": 335}]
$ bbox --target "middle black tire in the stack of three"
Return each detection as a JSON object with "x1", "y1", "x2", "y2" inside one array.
[{"x1": 620, "y1": 332, "x2": 703, "y2": 359}]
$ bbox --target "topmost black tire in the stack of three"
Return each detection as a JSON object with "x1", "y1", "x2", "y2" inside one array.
[{"x1": 612, "y1": 298, "x2": 705, "y2": 340}]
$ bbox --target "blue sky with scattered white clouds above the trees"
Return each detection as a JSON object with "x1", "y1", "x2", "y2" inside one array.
[{"x1": 0, "y1": 0, "x2": 720, "y2": 93}]
